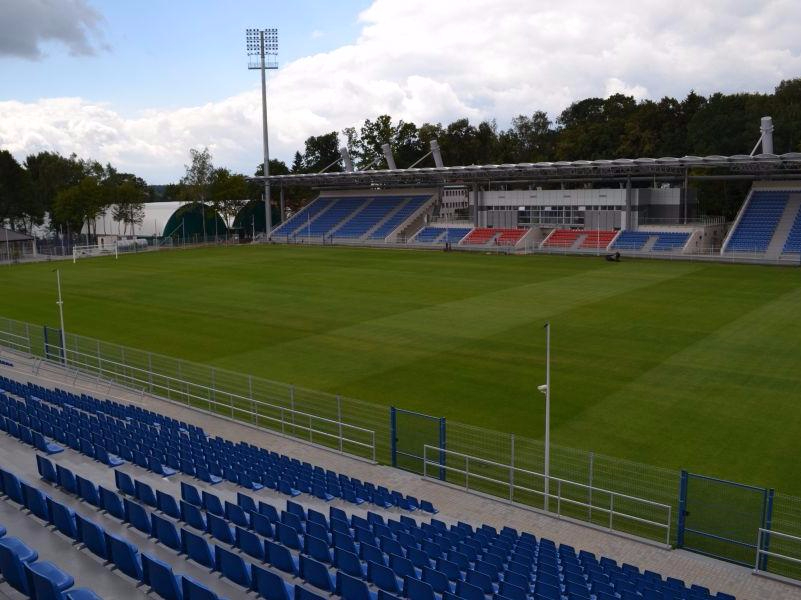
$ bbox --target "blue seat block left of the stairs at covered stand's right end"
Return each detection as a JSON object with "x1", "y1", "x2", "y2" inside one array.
[{"x1": 726, "y1": 190, "x2": 789, "y2": 252}]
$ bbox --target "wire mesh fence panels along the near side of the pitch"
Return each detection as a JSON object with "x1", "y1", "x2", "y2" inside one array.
[{"x1": 0, "y1": 317, "x2": 801, "y2": 560}]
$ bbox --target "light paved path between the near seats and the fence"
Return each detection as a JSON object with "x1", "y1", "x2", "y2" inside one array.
[{"x1": 0, "y1": 352, "x2": 801, "y2": 600}]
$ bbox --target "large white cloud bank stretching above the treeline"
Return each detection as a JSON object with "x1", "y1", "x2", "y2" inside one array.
[{"x1": 0, "y1": 0, "x2": 801, "y2": 181}]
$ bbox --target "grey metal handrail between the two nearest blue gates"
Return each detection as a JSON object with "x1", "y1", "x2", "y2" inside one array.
[{"x1": 423, "y1": 444, "x2": 673, "y2": 546}]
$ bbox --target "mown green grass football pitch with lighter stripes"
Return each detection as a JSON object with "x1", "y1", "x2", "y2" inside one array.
[{"x1": 0, "y1": 246, "x2": 801, "y2": 494}]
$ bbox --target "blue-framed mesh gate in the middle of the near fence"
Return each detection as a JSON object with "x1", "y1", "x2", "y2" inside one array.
[{"x1": 389, "y1": 406, "x2": 445, "y2": 481}]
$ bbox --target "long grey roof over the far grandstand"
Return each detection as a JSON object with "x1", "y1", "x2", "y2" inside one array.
[{"x1": 251, "y1": 152, "x2": 801, "y2": 188}]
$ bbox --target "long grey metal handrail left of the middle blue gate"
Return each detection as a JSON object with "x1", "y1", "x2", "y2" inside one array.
[{"x1": 45, "y1": 342, "x2": 376, "y2": 461}]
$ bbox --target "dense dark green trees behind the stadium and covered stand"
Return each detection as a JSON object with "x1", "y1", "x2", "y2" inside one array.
[{"x1": 0, "y1": 78, "x2": 801, "y2": 232}]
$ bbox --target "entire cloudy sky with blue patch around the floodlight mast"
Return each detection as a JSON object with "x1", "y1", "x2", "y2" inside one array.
[{"x1": 0, "y1": 0, "x2": 801, "y2": 184}]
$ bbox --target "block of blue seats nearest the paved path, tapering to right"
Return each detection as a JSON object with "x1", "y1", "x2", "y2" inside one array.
[{"x1": 0, "y1": 378, "x2": 435, "y2": 512}]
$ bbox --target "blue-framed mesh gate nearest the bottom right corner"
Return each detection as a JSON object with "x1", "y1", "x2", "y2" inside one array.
[{"x1": 676, "y1": 471, "x2": 773, "y2": 567}]
